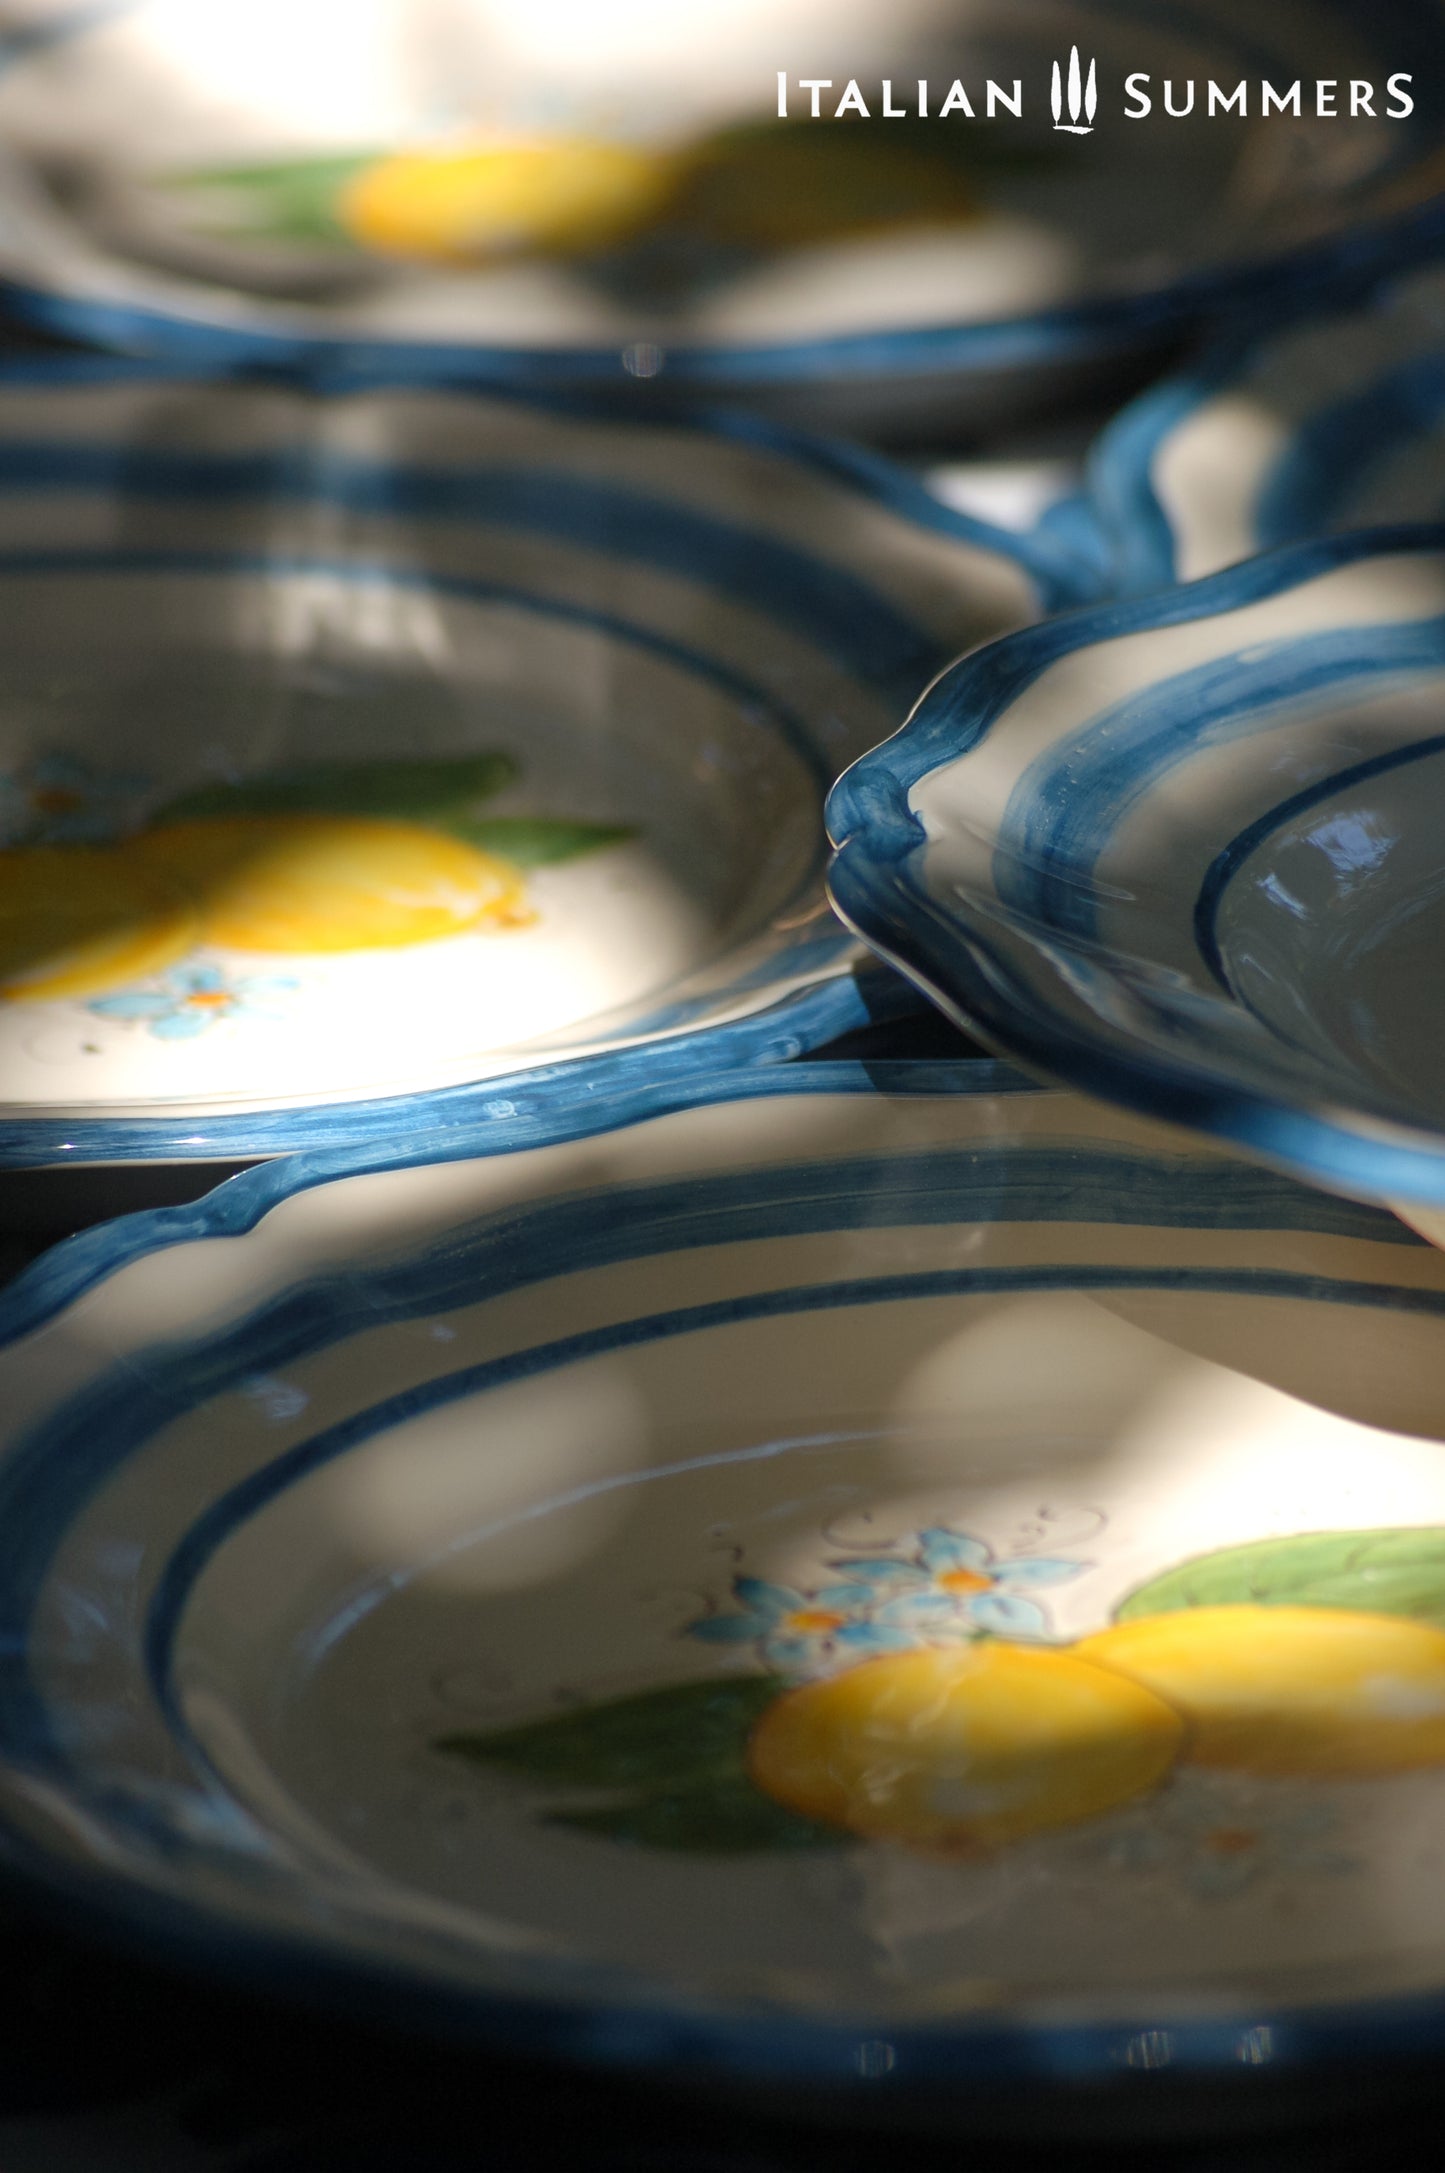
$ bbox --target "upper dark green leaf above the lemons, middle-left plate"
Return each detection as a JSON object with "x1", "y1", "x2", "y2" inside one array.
[{"x1": 154, "y1": 750, "x2": 517, "y2": 828}]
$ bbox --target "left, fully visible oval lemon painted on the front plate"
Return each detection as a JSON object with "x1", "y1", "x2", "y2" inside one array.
[{"x1": 747, "y1": 1641, "x2": 1184, "y2": 1856}]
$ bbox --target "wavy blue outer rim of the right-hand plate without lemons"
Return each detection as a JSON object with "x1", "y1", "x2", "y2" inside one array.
[{"x1": 828, "y1": 526, "x2": 1445, "y2": 1204}]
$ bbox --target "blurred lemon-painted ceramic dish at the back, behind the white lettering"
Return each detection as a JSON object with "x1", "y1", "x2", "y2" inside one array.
[{"x1": 0, "y1": 0, "x2": 1438, "y2": 443}]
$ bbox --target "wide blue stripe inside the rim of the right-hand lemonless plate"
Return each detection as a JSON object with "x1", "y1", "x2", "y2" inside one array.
[{"x1": 993, "y1": 615, "x2": 1445, "y2": 937}]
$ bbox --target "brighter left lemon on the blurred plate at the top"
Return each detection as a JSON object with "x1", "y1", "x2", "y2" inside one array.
[{"x1": 337, "y1": 137, "x2": 674, "y2": 263}]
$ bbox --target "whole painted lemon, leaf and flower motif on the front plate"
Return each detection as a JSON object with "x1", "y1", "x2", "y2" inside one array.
[{"x1": 439, "y1": 1525, "x2": 1445, "y2": 1860}]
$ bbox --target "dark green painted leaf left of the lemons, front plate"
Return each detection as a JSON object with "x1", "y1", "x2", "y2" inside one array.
[{"x1": 437, "y1": 1675, "x2": 847, "y2": 1856}]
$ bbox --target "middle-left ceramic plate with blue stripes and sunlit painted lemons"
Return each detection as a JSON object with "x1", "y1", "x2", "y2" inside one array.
[{"x1": 0, "y1": 365, "x2": 1063, "y2": 1165}]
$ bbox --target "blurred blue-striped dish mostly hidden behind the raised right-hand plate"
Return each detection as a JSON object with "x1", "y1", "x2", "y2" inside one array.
[{"x1": 1091, "y1": 269, "x2": 1445, "y2": 595}]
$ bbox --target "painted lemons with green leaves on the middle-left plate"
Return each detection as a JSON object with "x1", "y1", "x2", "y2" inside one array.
[{"x1": 0, "y1": 754, "x2": 630, "y2": 1019}]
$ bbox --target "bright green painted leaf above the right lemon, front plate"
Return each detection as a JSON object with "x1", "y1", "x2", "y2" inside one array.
[{"x1": 1115, "y1": 1525, "x2": 1445, "y2": 1628}]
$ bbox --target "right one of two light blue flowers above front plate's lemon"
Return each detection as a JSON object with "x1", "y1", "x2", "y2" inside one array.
[{"x1": 832, "y1": 1525, "x2": 1089, "y2": 1645}]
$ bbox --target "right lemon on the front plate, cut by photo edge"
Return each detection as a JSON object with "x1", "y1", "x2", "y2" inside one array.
[{"x1": 1073, "y1": 1606, "x2": 1445, "y2": 1773}]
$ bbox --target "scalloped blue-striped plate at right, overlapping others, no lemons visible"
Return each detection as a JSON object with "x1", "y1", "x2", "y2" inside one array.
[{"x1": 828, "y1": 528, "x2": 1445, "y2": 1213}]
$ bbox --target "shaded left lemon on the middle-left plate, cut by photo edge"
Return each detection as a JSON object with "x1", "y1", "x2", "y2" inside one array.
[{"x1": 0, "y1": 845, "x2": 196, "y2": 1002}]
